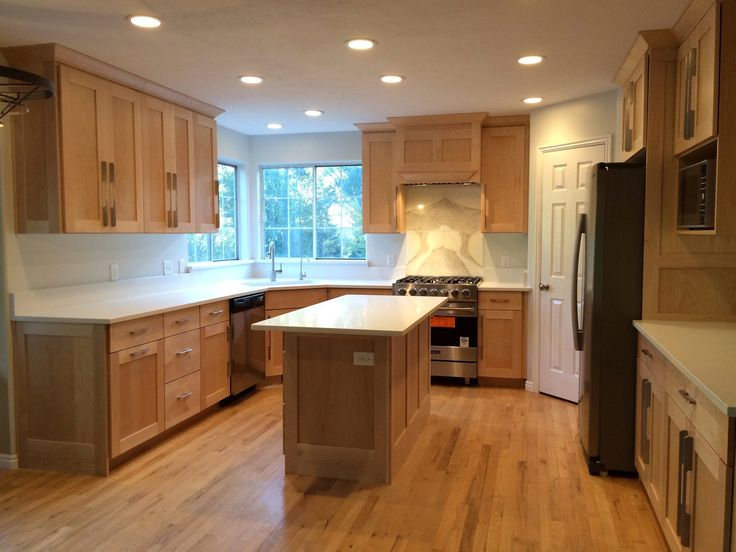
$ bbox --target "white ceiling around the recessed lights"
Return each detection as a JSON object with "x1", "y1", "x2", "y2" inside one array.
[{"x1": 0, "y1": 0, "x2": 687, "y2": 134}]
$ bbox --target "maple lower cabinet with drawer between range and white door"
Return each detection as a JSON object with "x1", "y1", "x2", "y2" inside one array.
[{"x1": 478, "y1": 291, "x2": 526, "y2": 385}]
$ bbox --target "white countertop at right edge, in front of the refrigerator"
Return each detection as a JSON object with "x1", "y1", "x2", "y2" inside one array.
[{"x1": 634, "y1": 320, "x2": 736, "y2": 416}]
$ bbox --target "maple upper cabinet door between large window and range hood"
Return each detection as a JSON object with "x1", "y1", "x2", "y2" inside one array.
[{"x1": 362, "y1": 132, "x2": 403, "y2": 234}]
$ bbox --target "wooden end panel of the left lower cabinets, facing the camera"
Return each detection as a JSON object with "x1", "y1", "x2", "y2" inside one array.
[{"x1": 13, "y1": 322, "x2": 109, "y2": 475}]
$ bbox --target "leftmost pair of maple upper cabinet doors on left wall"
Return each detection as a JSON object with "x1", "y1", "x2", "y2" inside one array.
[{"x1": 59, "y1": 65, "x2": 143, "y2": 232}]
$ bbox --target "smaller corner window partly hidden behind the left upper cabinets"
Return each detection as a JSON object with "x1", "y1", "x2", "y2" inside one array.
[{"x1": 187, "y1": 163, "x2": 238, "y2": 263}]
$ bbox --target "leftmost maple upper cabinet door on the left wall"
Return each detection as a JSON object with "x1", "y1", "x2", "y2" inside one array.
[{"x1": 59, "y1": 65, "x2": 110, "y2": 232}]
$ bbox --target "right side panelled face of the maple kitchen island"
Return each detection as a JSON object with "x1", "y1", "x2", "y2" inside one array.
[{"x1": 391, "y1": 319, "x2": 430, "y2": 484}]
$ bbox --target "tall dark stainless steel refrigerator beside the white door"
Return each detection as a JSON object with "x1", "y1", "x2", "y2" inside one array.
[{"x1": 570, "y1": 163, "x2": 644, "y2": 474}]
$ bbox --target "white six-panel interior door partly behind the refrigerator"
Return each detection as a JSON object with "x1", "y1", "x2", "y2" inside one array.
[{"x1": 539, "y1": 141, "x2": 608, "y2": 403}]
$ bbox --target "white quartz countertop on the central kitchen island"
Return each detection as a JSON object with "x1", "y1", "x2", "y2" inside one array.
[{"x1": 251, "y1": 295, "x2": 447, "y2": 336}]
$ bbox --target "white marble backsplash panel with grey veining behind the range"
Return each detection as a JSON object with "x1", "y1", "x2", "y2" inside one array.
[{"x1": 406, "y1": 184, "x2": 483, "y2": 276}]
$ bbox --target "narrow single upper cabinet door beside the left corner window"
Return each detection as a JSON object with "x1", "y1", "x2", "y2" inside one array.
[{"x1": 194, "y1": 114, "x2": 220, "y2": 232}]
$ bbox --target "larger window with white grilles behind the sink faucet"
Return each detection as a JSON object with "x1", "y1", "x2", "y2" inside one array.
[{"x1": 261, "y1": 165, "x2": 365, "y2": 259}]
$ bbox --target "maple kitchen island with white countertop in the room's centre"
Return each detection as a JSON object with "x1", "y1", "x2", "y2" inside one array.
[{"x1": 252, "y1": 295, "x2": 445, "y2": 483}]
